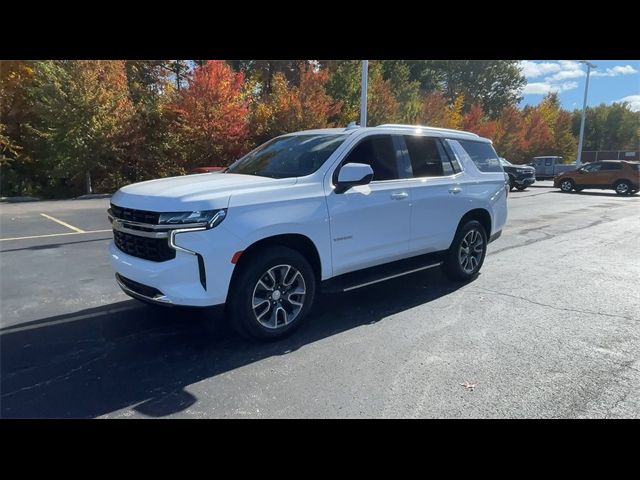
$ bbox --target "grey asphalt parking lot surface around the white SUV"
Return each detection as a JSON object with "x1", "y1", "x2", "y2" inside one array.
[{"x1": 0, "y1": 182, "x2": 640, "y2": 418}]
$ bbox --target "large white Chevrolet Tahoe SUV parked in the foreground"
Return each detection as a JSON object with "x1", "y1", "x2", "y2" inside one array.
[{"x1": 109, "y1": 125, "x2": 508, "y2": 339}]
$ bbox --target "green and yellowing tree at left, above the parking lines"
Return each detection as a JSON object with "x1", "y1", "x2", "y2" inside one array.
[{"x1": 29, "y1": 60, "x2": 133, "y2": 193}]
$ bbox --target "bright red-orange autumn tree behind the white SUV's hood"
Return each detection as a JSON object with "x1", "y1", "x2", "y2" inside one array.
[{"x1": 171, "y1": 60, "x2": 249, "y2": 166}]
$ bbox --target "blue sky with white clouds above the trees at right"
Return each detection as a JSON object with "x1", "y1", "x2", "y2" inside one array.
[{"x1": 520, "y1": 60, "x2": 640, "y2": 111}]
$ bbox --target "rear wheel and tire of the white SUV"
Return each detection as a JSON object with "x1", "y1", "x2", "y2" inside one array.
[{"x1": 442, "y1": 220, "x2": 487, "y2": 282}]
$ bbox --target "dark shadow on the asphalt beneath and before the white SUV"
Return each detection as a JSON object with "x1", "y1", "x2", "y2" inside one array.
[{"x1": 0, "y1": 269, "x2": 464, "y2": 418}]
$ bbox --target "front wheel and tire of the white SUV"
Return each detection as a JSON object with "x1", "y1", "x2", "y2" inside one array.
[{"x1": 227, "y1": 246, "x2": 316, "y2": 340}]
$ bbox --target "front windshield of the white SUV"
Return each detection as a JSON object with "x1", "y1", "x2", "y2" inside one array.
[{"x1": 226, "y1": 134, "x2": 347, "y2": 178}]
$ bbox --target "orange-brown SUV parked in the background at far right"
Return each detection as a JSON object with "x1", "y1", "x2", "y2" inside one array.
[{"x1": 553, "y1": 160, "x2": 640, "y2": 195}]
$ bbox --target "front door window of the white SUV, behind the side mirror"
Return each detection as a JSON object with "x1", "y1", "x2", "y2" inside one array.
[{"x1": 342, "y1": 135, "x2": 400, "y2": 182}]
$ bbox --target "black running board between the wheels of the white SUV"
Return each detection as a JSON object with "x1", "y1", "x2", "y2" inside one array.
[{"x1": 322, "y1": 253, "x2": 443, "y2": 293}]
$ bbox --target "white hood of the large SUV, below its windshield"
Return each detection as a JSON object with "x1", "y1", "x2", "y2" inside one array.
[{"x1": 111, "y1": 173, "x2": 297, "y2": 212}]
